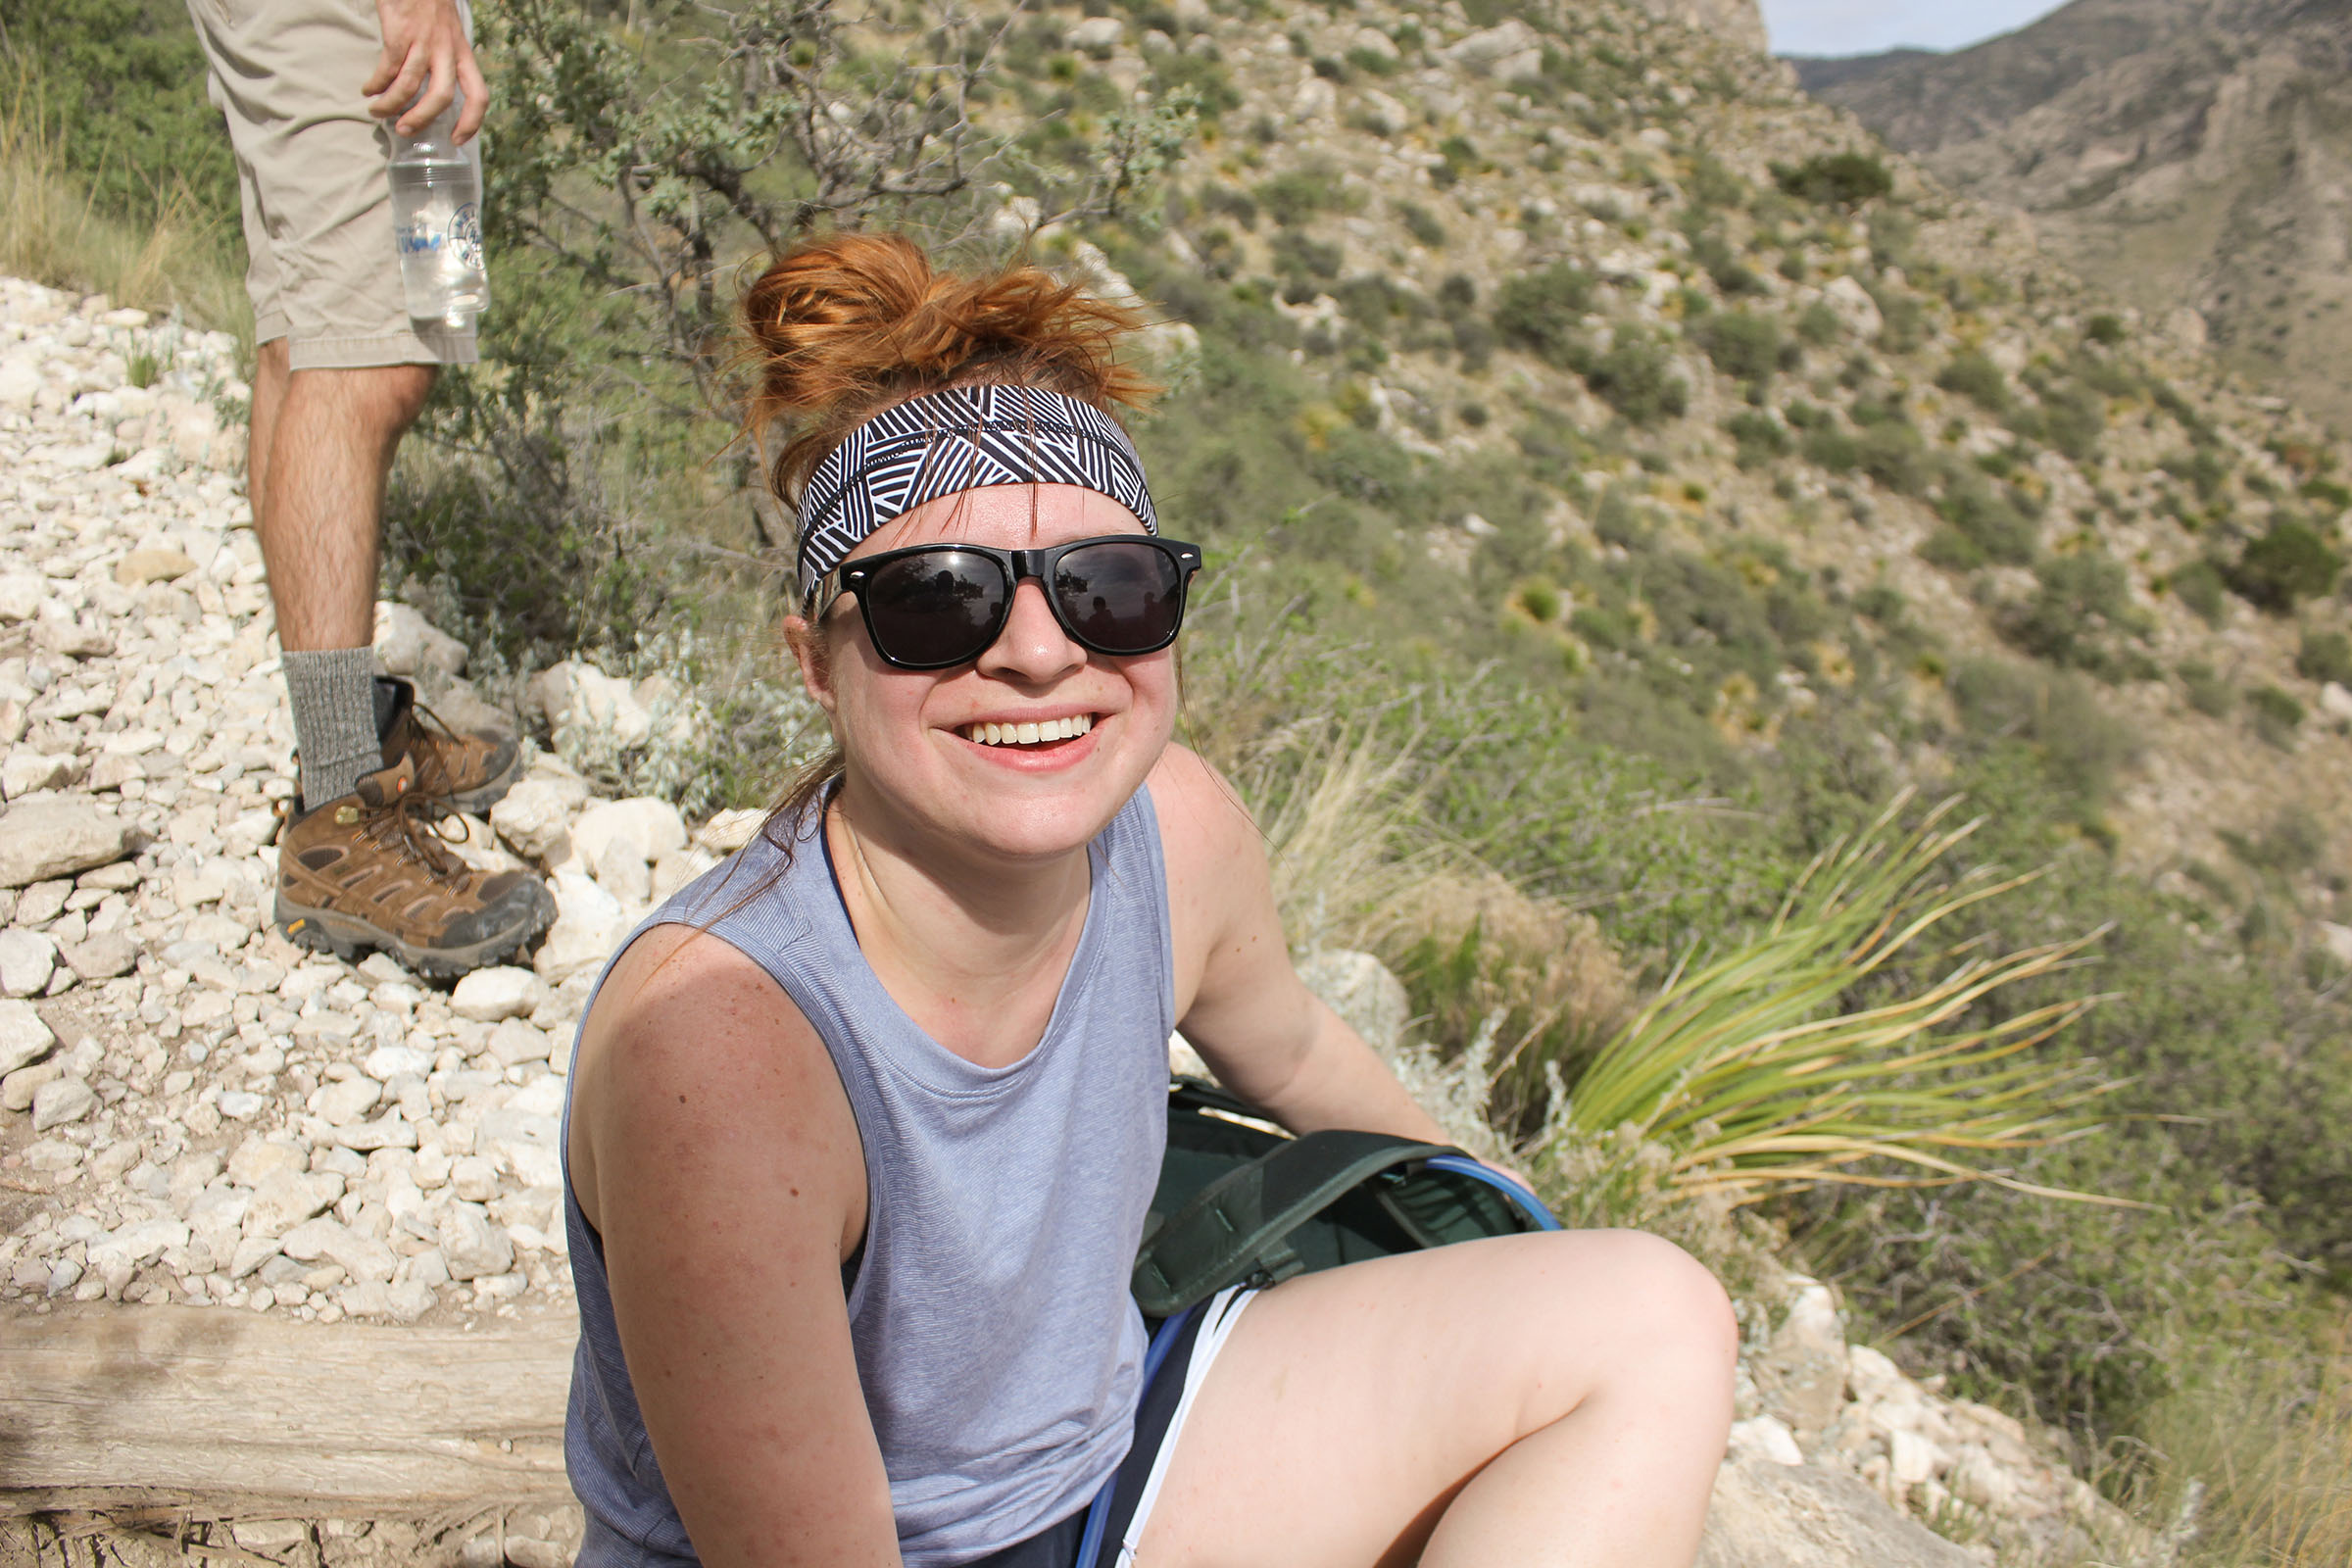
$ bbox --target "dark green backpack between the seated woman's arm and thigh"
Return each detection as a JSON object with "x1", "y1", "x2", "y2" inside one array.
[{"x1": 1131, "y1": 1079, "x2": 1559, "y2": 1319}]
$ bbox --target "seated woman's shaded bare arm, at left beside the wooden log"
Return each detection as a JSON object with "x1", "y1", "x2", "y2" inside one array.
[{"x1": 569, "y1": 926, "x2": 899, "y2": 1568}]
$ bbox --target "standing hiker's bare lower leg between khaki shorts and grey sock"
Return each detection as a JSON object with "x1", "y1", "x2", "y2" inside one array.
[{"x1": 247, "y1": 355, "x2": 433, "y2": 649}]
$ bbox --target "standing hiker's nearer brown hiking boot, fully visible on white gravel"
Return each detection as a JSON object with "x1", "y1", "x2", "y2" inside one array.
[{"x1": 277, "y1": 757, "x2": 555, "y2": 978}]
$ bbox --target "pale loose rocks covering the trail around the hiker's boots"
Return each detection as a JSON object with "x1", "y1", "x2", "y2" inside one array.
[{"x1": 0, "y1": 282, "x2": 758, "y2": 1321}]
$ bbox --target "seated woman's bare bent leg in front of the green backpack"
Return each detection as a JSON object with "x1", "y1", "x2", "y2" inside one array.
[{"x1": 1139, "y1": 1232, "x2": 1739, "y2": 1568}]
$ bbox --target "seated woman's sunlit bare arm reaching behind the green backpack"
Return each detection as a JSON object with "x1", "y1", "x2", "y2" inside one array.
[{"x1": 1151, "y1": 745, "x2": 1446, "y2": 1143}]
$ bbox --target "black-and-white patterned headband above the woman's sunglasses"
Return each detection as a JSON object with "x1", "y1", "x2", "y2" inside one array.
[{"x1": 800, "y1": 385, "x2": 1159, "y2": 604}]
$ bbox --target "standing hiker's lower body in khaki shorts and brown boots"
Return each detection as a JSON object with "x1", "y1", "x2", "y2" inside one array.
[{"x1": 188, "y1": 0, "x2": 553, "y2": 973}]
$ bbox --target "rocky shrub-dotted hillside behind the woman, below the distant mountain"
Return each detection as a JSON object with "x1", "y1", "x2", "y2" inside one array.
[{"x1": 1067, "y1": 0, "x2": 2352, "y2": 919}]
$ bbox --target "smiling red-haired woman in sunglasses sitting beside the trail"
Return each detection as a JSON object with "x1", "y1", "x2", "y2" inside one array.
[{"x1": 564, "y1": 235, "x2": 1736, "y2": 1568}]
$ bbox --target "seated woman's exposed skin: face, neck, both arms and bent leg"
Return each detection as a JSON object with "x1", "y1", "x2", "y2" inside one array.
[{"x1": 566, "y1": 487, "x2": 1736, "y2": 1568}]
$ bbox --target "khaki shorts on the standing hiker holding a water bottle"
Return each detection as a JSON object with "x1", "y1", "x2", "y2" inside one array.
[{"x1": 188, "y1": 0, "x2": 477, "y2": 369}]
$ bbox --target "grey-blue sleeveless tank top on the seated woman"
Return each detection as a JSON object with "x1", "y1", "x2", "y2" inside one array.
[{"x1": 564, "y1": 790, "x2": 1176, "y2": 1568}]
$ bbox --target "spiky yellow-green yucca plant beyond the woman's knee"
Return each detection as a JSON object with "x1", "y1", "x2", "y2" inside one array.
[{"x1": 1547, "y1": 795, "x2": 2119, "y2": 1203}]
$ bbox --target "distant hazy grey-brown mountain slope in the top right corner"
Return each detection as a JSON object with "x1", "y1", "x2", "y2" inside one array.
[{"x1": 1797, "y1": 0, "x2": 2352, "y2": 423}]
